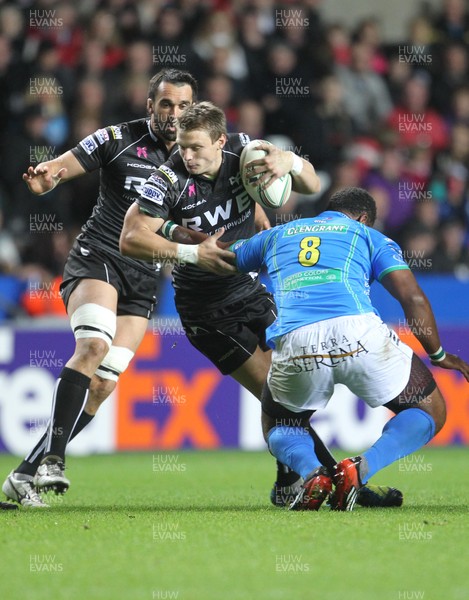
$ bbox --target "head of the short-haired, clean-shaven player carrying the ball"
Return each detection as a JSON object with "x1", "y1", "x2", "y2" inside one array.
[{"x1": 176, "y1": 102, "x2": 226, "y2": 178}]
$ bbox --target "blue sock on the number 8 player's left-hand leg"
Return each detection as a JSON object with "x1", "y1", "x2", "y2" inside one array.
[{"x1": 267, "y1": 426, "x2": 321, "y2": 479}]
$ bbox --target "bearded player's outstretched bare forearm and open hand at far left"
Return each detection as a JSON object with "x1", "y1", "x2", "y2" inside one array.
[{"x1": 23, "y1": 150, "x2": 86, "y2": 195}]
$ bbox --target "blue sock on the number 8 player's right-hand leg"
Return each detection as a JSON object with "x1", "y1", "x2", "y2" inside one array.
[{"x1": 362, "y1": 408, "x2": 435, "y2": 483}]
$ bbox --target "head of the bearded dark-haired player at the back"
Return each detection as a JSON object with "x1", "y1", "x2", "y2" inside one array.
[{"x1": 147, "y1": 69, "x2": 198, "y2": 146}]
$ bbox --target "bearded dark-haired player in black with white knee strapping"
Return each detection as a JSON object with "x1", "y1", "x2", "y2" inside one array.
[{"x1": 2, "y1": 69, "x2": 207, "y2": 507}]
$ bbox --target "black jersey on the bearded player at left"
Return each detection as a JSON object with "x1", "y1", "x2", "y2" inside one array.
[{"x1": 72, "y1": 119, "x2": 177, "y2": 273}]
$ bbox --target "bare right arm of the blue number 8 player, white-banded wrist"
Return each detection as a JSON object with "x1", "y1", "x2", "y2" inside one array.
[{"x1": 381, "y1": 269, "x2": 469, "y2": 381}]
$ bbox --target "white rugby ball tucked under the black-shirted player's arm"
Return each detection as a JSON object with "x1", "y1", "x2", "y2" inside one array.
[{"x1": 239, "y1": 140, "x2": 292, "y2": 208}]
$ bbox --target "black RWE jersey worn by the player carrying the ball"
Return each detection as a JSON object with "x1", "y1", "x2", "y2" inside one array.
[{"x1": 137, "y1": 133, "x2": 260, "y2": 313}]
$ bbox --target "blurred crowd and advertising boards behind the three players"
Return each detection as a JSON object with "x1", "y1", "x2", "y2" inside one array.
[{"x1": 0, "y1": 0, "x2": 469, "y2": 454}]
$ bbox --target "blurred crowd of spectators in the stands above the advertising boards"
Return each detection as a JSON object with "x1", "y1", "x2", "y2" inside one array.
[{"x1": 0, "y1": 0, "x2": 469, "y2": 318}]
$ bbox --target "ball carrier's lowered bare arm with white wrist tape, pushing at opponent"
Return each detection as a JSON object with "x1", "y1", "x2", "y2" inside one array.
[{"x1": 119, "y1": 203, "x2": 236, "y2": 275}]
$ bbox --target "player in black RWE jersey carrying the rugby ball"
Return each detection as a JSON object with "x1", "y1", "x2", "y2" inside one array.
[{"x1": 120, "y1": 102, "x2": 402, "y2": 504}]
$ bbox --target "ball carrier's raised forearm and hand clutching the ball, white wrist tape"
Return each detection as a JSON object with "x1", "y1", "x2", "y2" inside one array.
[{"x1": 245, "y1": 143, "x2": 321, "y2": 194}]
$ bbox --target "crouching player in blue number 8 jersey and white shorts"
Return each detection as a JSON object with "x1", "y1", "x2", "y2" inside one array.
[{"x1": 230, "y1": 188, "x2": 469, "y2": 510}]
